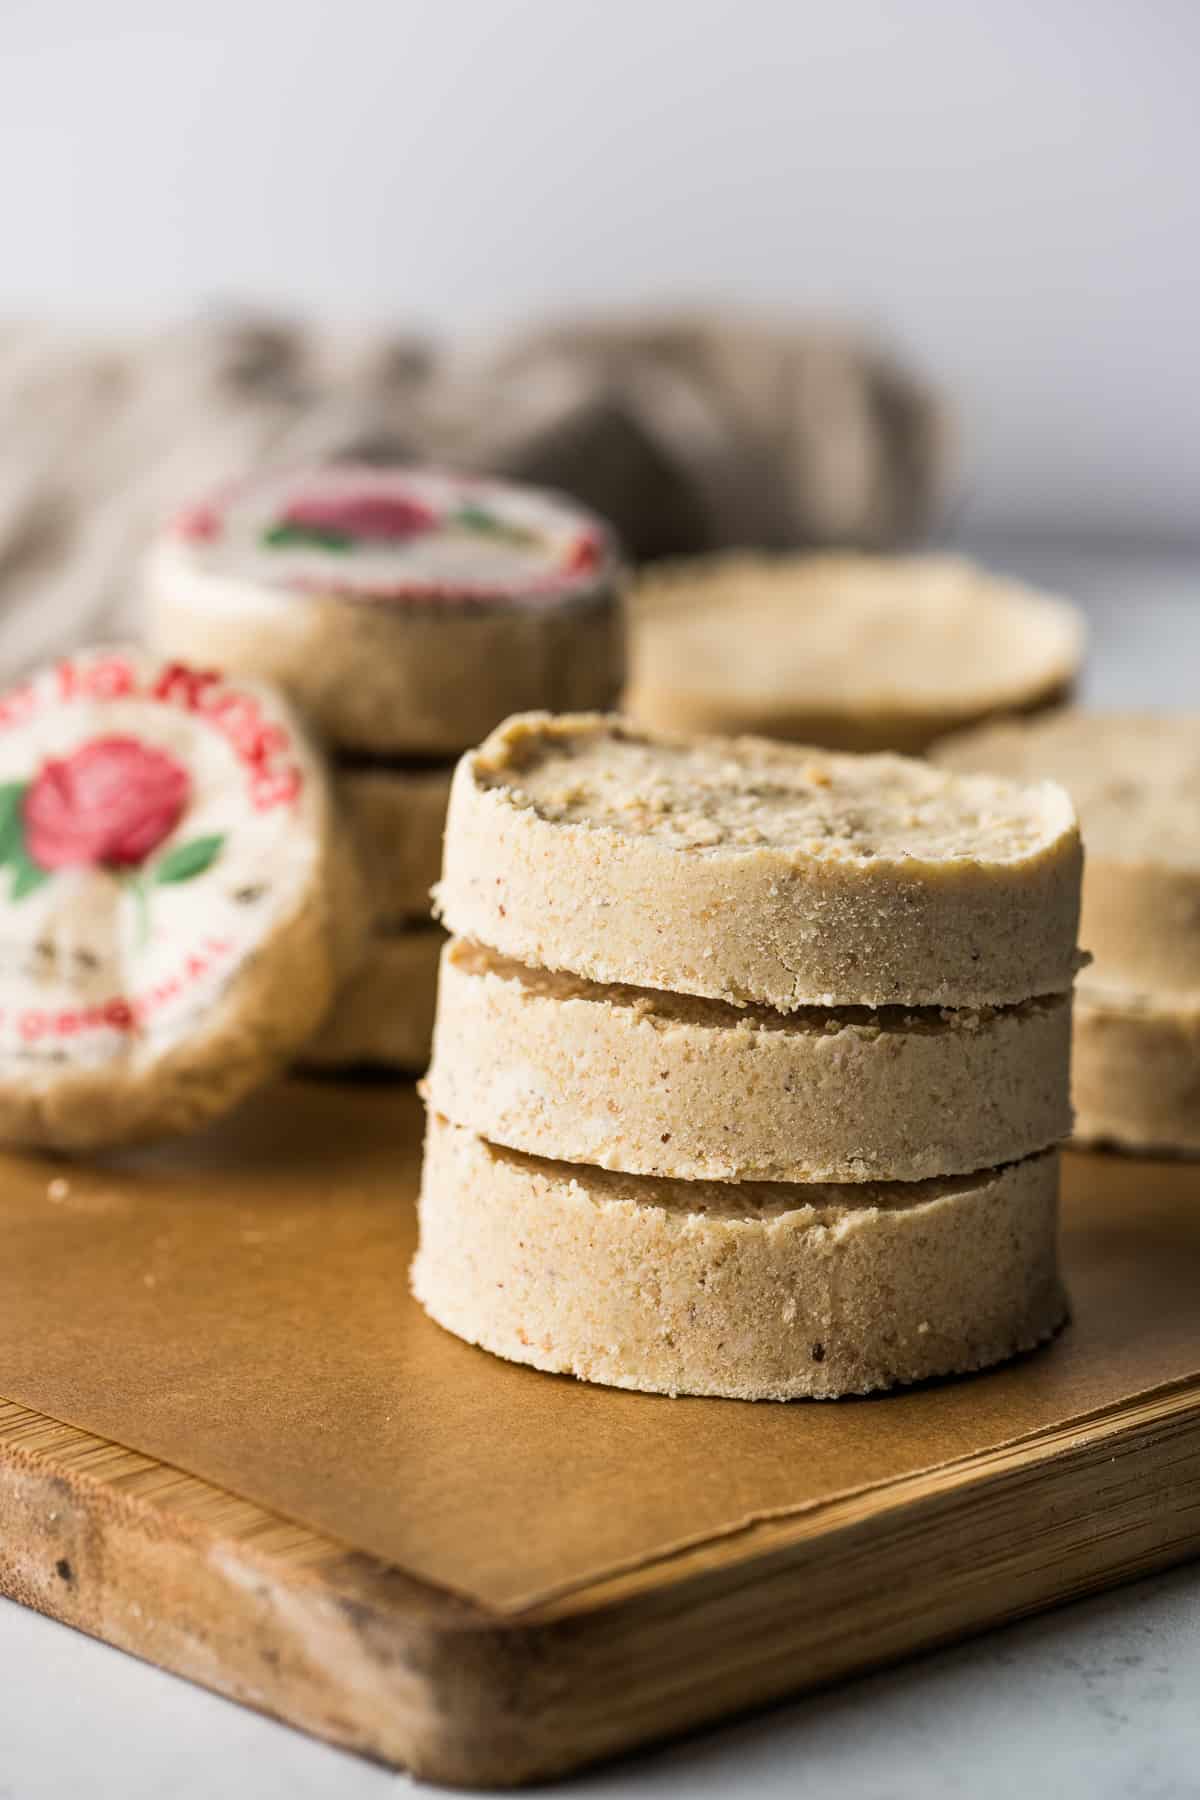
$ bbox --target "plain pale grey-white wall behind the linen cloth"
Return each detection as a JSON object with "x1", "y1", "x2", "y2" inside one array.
[{"x1": 0, "y1": 0, "x2": 1200, "y2": 540}]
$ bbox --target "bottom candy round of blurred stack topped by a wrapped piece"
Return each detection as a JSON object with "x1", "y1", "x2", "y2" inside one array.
[{"x1": 299, "y1": 925, "x2": 446, "y2": 1075}]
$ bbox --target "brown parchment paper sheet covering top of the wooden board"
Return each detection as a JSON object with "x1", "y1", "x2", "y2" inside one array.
[{"x1": 0, "y1": 1082, "x2": 1200, "y2": 1611}]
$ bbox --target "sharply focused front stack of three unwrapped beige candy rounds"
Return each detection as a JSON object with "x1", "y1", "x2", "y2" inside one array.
[{"x1": 412, "y1": 715, "x2": 1081, "y2": 1399}]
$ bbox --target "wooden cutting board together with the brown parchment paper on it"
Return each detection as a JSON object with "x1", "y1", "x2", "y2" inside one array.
[{"x1": 0, "y1": 1084, "x2": 1200, "y2": 1786}]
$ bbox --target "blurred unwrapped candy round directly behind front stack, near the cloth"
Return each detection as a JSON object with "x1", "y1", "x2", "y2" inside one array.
[{"x1": 626, "y1": 553, "x2": 1085, "y2": 752}]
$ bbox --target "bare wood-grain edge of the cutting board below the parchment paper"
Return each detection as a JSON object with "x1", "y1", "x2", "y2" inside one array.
[{"x1": 0, "y1": 1388, "x2": 1200, "y2": 1787}]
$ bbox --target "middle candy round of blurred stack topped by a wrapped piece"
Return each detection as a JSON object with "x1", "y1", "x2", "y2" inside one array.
[{"x1": 335, "y1": 763, "x2": 453, "y2": 931}]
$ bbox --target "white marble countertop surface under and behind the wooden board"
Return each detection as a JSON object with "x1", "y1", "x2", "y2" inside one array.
[{"x1": 0, "y1": 542, "x2": 1200, "y2": 1800}]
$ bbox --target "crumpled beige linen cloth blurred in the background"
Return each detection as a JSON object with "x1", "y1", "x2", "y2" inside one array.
[{"x1": 0, "y1": 313, "x2": 948, "y2": 675}]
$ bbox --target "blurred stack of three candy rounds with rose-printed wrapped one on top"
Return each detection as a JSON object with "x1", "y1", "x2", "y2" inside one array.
[{"x1": 146, "y1": 464, "x2": 624, "y2": 1071}]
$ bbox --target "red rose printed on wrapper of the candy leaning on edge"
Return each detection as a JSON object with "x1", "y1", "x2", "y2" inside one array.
[{"x1": 22, "y1": 738, "x2": 191, "y2": 869}]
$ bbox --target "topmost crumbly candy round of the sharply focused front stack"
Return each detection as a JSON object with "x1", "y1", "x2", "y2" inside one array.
[{"x1": 435, "y1": 715, "x2": 1081, "y2": 1012}]
